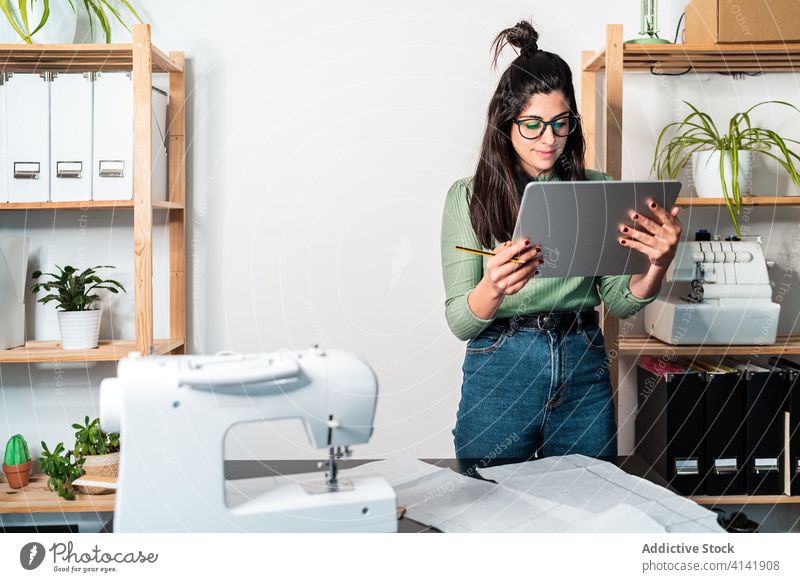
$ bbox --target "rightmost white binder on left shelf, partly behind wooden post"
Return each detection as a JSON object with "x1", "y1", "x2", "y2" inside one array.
[{"x1": 92, "y1": 73, "x2": 167, "y2": 200}]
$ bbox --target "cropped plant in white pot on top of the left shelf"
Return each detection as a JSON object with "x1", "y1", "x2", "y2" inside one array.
[{"x1": 0, "y1": 0, "x2": 141, "y2": 44}]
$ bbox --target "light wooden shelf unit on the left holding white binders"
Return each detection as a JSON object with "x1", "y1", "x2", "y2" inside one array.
[{"x1": 0, "y1": 24, "x2": 186, "y2": 363}]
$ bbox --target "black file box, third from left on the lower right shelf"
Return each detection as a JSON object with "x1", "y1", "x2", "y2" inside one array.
[{"x1": 744, "y1": 368, "x2": 789, "y2": 495}]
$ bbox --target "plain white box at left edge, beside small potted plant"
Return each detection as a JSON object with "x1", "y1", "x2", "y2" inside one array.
[{"x1": 0, "y1": 235, "x2": 28, "y2": 350}]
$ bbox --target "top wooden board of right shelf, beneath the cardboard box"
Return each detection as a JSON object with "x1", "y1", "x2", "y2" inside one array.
[{"x1": 584, "y1": 43, "x2": 800, "y2": 73}]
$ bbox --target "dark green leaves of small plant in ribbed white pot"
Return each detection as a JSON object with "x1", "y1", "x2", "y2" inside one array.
[{"x1": 31, "y1": 265, "x2": 125, "y2": 311}]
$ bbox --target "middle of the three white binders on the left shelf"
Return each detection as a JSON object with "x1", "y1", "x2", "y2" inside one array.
[{"x1": 50, "y1": 73, "x2": 92, "y2": 202}]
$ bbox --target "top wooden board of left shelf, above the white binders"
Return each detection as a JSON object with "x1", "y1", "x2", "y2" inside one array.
[{"x1": 0, "y1": 43, "x2": 183, "y2": 73}]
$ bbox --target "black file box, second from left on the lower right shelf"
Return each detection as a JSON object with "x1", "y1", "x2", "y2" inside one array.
[{"x1": 702, "y1": 372, "x2": 747, "y2": 495}]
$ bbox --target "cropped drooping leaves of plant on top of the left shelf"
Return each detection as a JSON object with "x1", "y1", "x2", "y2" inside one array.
[{"x1": 0, "y1": 0, "x2": 142, "y2": 44}]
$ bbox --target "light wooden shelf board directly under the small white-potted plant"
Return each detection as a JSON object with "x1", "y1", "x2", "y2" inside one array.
[{"x1": 0, "y1": 338, "x2": 183, "y2": 364}]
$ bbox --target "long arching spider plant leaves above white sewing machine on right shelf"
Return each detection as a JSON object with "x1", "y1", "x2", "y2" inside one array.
[{"x1": 651, "y1": 101, "x2": 800, "y2": 236}]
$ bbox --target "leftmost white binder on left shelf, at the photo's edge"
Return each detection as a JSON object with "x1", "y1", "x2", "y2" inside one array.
[{"x1": 0, "y1": 73, "x2": 50, "y2": 202}]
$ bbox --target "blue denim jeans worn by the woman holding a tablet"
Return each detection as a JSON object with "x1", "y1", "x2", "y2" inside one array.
[{"x1": 452, "y1": 316, "x2": 617, "y2": 460}]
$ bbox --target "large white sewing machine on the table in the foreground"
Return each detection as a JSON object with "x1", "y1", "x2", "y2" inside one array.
[{"x1": 100, "y1": 347, "x2": 397, "y2": 532}]
